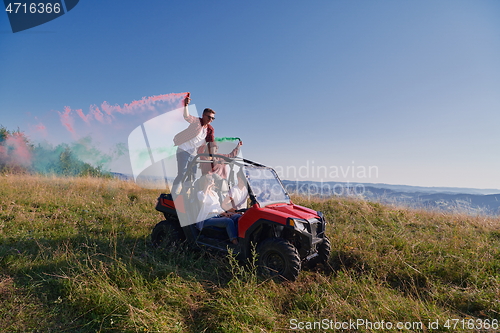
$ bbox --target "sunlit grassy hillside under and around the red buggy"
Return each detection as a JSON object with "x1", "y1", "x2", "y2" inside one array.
[{"x1": 0, "y1": 175, "x2": 500, "y2": 332}]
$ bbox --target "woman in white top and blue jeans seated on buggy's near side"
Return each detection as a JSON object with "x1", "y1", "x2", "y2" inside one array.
[{"x1": 196, "y1": 174, "x2": 241, "y2": 244}]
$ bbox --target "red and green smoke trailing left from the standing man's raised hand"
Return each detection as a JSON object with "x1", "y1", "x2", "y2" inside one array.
[{"x1": 0, "y1": 93, "x2": 191, "y2": 174}]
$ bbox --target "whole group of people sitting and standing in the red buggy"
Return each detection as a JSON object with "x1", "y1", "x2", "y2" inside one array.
[{"x1": 171, "y1": 94, "x2": 248, "y2": 244}]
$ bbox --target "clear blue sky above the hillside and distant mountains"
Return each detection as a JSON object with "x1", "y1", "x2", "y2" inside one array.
[{"x1": 0, "y1": 0, "x2": 500, "y2": 189}]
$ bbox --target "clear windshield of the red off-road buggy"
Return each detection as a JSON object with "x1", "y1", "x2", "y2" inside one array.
[{"x1": 245, "y1": 166, "x2": 290, "y2": 207}]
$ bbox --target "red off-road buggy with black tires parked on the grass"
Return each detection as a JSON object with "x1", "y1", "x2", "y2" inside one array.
[{"x1": 151, "y1": 154, "x2": 330, "y2": 281}]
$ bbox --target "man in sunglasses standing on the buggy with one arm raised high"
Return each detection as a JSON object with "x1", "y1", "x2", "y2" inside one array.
[{"x1": 171, "y1": 93, "x2": 215, "y2": 195}]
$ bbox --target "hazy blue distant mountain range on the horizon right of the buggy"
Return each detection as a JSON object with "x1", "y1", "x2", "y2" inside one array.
[{"x1": 282, "y1": 180, "x2": 500, "y2": 215}]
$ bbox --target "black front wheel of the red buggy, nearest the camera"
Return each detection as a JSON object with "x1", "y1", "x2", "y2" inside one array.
[{"x1": 257, "y1": 238, "x2": 300, "y2": 281}]
